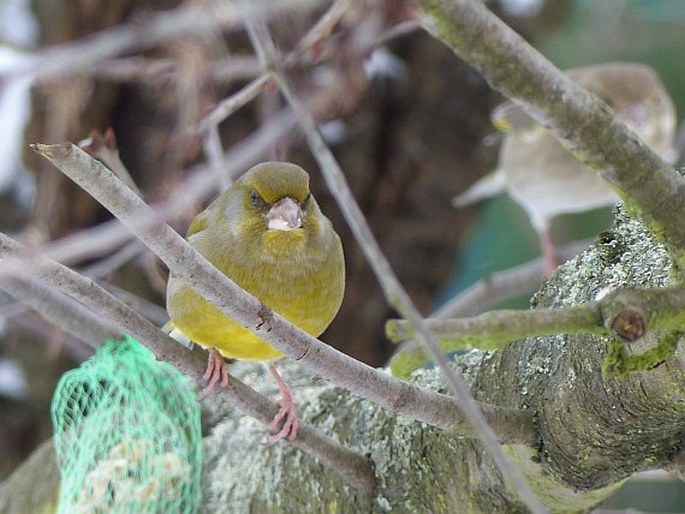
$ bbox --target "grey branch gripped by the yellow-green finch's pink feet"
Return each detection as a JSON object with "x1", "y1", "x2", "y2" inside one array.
[{"x1": 0, "y1": 234, "x2": 375, "y2": 491}]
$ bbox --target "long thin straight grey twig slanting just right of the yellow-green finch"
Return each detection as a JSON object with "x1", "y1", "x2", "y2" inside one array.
[{"x1": 246, "y1": 16, "x2": 547, "y2": 513}]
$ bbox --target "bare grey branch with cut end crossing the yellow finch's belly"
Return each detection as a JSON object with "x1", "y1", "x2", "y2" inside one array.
[{"x1": 29, "y1": 143, "x2": 537, "y2": 444}]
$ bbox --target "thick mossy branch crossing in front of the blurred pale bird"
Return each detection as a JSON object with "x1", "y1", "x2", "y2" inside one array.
[{"x1": 414, "y1": 0, "x2": 685, "y2": 273}]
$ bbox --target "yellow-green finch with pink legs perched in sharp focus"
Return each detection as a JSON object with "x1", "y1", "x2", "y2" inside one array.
[{"x1": 167, "y1": 162, "x2": 345, "y2": 442}]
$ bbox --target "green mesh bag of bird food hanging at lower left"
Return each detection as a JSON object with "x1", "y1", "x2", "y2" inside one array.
[{"x1": 51, "y1": 338, "x2": 202, "y2": 514}]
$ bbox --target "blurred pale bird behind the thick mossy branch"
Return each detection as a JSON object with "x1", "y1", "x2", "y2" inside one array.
[{"x1": 454, "y1": 62, "x2": 676, "y2": 275}]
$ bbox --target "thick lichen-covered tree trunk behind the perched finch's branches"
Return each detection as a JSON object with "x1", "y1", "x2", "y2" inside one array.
[{"x1": 198, "y1": 203, "x2": 685, "y2": 512}]
